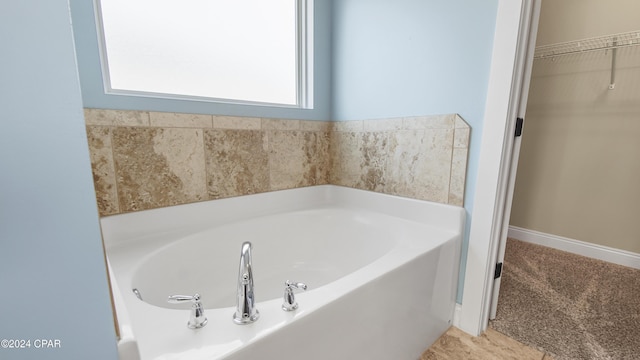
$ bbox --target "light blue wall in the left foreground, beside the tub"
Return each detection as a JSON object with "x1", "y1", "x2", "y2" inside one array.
[{"x1": 0, "y1": 0, "x2": 117, "y2": 360}]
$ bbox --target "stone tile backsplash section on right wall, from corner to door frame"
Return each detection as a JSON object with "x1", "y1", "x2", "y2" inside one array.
[{"x1": 329, "y1": 114, "x2": 469, "y2": 205}]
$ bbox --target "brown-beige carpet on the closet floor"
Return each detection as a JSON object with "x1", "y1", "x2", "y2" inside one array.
[{"x1": 489, "y1": 239, "x2": 640, "y2": 360}]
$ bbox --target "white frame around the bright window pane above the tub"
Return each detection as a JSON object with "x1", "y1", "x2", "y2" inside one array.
[{"x1": 94, "y1": 0, "x2": 314, "y2": 109}]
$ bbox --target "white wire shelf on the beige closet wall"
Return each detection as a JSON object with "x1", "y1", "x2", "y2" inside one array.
[{"x1": 533, "y1": 30, "x2": 640, "y2": 59}]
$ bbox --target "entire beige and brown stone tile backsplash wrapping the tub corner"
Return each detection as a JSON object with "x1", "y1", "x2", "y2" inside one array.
[{"x1": 85, "y1": 109, "x2": 470, "y2": 216}]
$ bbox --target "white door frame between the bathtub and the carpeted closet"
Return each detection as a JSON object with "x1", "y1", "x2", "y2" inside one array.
[{"x1": 458, "y1": 0, "x2": 540, "y2": 336}]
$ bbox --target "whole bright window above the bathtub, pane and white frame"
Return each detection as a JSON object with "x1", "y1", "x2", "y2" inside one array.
[{"x1": 96, "y1": 0, "x2": 313, "y2": 108}]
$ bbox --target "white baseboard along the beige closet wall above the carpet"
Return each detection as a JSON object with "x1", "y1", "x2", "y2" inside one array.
[{"x1": 508, "y1": 226, "x2": 640, "y2": 269}]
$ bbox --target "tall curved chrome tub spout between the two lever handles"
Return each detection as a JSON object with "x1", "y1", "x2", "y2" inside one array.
[{"x1": 233, "y1": 241, "x2": 260, "y2": 325}]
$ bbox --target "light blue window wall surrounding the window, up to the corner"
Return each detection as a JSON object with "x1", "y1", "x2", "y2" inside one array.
[{"x1": 70, "y1": 0, "x2": 332, "y2": 120}]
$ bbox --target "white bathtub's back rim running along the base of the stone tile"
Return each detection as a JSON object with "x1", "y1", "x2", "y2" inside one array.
[{"x1": 100, "y1": 185, "x2": 465, "y2": 250}]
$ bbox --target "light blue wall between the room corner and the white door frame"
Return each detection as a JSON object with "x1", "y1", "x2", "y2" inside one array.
[{"x1": 332, "y1": 0, "x2": 498, "y2": 302}]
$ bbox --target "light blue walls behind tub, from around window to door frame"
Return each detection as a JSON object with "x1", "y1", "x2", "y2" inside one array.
[{"x1": 71, "y1": 0, "x2": 498, "y2": 310}]
